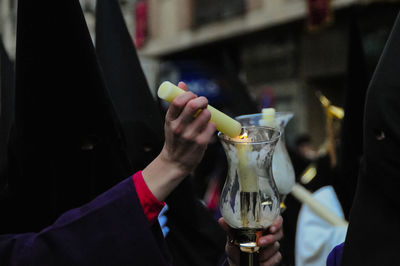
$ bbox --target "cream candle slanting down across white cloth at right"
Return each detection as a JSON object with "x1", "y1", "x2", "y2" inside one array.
[{"x1": 292, "y1": 184, "x2": 348, "y2": 226}]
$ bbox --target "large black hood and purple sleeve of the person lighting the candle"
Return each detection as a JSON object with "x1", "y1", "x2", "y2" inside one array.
[{"x1": 0, "y1": 0, "x2": 170, "y2": 266}]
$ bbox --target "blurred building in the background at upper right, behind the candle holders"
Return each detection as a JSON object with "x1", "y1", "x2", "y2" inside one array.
[{"x1": 133, "y1": 0, "x2": 399, "y2": 150}]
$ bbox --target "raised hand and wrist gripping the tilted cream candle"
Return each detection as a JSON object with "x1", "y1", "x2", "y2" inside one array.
[{"x1": 142, "y1": 82, "x2": 216, "y2": 201}]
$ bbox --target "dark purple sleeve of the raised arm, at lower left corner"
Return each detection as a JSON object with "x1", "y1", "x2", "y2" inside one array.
[{"x1": 0, "y1": 177, "x2": 168, "y2": 266}]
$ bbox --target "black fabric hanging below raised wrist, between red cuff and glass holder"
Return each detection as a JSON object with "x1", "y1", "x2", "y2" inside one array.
[{"x1": 166, "y1": 179, "x2": 226, "y2": 266}]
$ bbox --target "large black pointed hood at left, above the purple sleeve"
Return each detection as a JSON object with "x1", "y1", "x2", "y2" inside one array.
[{"x1": 1, "y1": 0, "x2": 132, "y2": 232}]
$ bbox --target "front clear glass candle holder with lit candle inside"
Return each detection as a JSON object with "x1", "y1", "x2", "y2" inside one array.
[{"x1": 218, "y1": 126, "x2": 281, "y2": 265}]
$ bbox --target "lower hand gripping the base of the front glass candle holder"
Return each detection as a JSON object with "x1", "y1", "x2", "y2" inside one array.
[{"x1": 218, "y1": 216, "x2": 283, "y2": 266}]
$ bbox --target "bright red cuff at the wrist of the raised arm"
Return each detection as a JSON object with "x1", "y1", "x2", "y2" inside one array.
[{"x1": 132, "y1": 171, "x2": 165, "y2": 224}]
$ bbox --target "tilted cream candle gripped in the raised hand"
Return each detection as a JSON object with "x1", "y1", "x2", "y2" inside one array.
[{"x1": 157, "y1": 81, "x2": 242, "y2": 138}]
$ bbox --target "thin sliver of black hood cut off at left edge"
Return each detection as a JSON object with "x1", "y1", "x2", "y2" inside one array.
[{"x1": 0, "y1": 35, "x2": 15, "y2": 193}]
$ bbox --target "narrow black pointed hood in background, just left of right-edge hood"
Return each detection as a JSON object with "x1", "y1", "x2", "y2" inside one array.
[{"x1": 334, "y1": 9, "x2": 370, "y2": 219}]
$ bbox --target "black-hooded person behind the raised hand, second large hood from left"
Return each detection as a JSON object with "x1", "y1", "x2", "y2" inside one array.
[{"x1": 96, "y1": 0, "x2": 225, "y2": 266}]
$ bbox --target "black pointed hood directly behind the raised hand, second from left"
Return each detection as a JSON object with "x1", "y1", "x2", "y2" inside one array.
[{"x1": 96, "y1": 0, "x2": 164, "y2": 170}]
